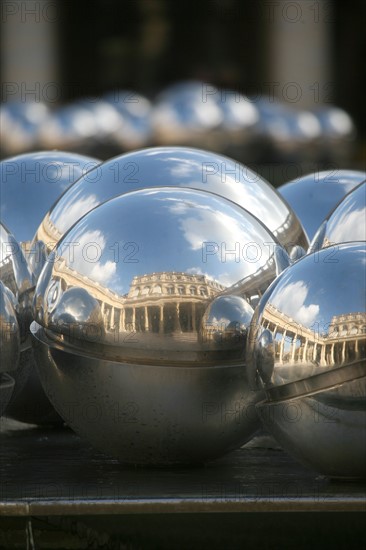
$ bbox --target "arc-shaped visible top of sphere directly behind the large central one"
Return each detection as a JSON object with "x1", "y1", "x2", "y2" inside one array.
[{"x1": 36, "y1": 147, "x2": 308, "y2": 260}]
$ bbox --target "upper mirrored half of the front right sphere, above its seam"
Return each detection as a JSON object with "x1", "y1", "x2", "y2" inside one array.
[{"x1": 247, "y1": 243, "x2": 366, "y2": 397}]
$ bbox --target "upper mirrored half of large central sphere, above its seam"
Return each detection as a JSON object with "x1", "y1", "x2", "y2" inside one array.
[{"x1": 35, "y1": 188, "x2": 288, "y2": 364}]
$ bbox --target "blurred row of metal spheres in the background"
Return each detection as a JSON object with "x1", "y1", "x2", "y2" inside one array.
[{"x1": 0, "y1": 81, "x2": 355, "y2": 163}]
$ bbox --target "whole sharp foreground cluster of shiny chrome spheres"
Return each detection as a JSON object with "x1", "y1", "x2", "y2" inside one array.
[{"x1": 0, "y1": 147, "x2": 366, "y2": 477}]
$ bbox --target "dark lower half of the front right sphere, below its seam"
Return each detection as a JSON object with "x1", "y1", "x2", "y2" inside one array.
[{"x1": 257, "y1": 376, "x2": 366, "y2": 478}]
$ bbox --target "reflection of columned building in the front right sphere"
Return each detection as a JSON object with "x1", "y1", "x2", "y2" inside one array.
[{"x1": 261, "y1": 304, "x2": 366, "y2": 367}]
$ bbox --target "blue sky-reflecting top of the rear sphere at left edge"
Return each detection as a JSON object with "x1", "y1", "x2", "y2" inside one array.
[{"x1": 0, "y1": 151, "x2": 100, "y2": 243}]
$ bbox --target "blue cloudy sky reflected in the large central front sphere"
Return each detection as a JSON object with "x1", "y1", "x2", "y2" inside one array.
[{"x1": 53, "y1": 188, "x2": 274, "y2": 294}]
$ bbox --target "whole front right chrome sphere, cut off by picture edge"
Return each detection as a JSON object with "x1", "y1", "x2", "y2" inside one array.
[{"x1": 247, "y1": 243, "x2": 366, "y2": 477}]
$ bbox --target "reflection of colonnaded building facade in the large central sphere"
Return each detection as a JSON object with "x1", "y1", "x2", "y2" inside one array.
[{"x1": 54, "y1": 260, "x2": 225, "y2": 333}]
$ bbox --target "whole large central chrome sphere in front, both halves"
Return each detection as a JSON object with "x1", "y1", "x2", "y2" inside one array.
[{"x1": 32, "y1": 187, "x2": 288, "y2": 464}]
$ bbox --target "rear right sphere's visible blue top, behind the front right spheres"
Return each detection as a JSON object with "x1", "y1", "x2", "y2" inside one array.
[{"x1": 278, "y1": 170, "x2": 366, "y2": 240}]
